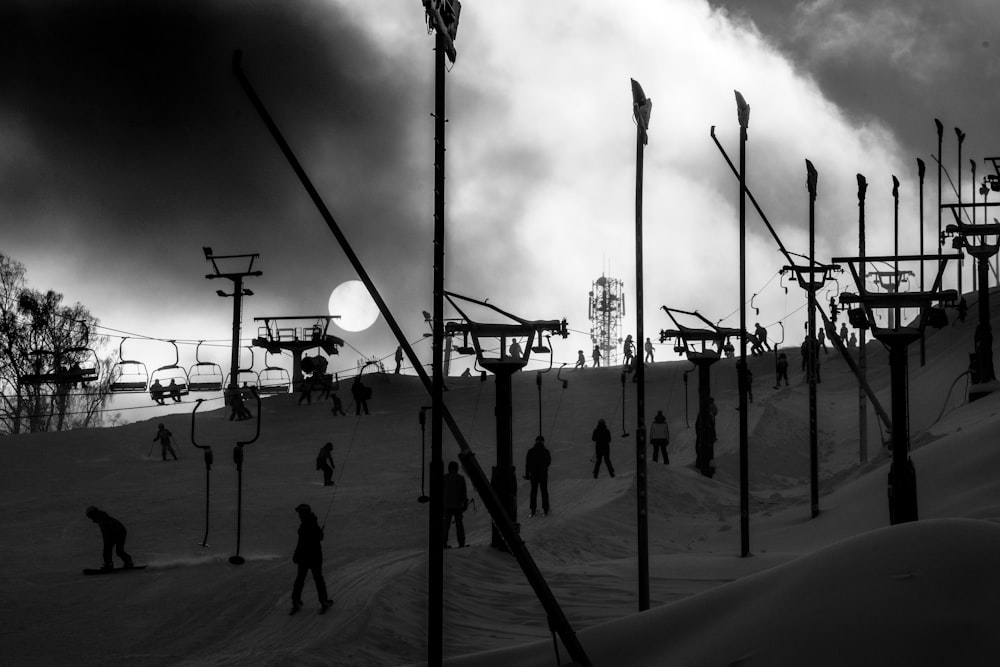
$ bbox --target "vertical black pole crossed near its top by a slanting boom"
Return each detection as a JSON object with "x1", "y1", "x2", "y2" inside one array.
[{"x1": 735, "y1": 91, "x2": 750, "y2": 558}]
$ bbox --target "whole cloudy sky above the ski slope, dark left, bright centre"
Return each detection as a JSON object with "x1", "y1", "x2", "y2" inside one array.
[{"x1": 0, "y1": 0, "x2": 1000, "y2": 380}]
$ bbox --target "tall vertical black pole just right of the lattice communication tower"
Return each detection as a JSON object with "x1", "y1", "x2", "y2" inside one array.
[{"x1": 632, "y1": 79, "x2": 653, "y2": 611}]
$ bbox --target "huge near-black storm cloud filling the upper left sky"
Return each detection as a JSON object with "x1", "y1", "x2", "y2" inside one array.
[{"x1": 0, "y1": 0, "x2": 431, "y2": 344}]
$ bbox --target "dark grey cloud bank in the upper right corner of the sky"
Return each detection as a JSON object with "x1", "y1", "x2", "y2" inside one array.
[{"x1": 709, "y1": 0, "x2": 1000, "y2": 164}]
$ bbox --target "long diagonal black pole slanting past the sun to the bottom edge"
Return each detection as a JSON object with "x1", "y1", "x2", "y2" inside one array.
[{"x1": 233, "y1": 51, "x2": 592, "y2": 667}]
